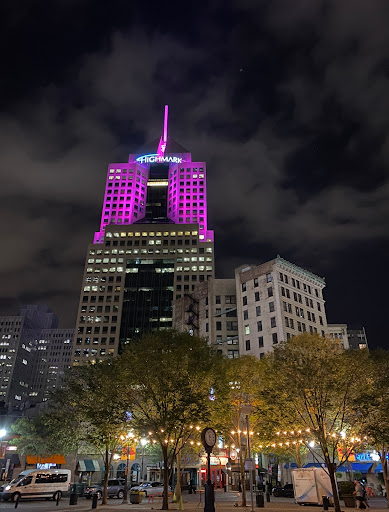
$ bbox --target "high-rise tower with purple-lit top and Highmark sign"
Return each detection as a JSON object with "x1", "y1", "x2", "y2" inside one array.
[{"x1": 73, "y1": 106, "x2": 214, "y2": 365}]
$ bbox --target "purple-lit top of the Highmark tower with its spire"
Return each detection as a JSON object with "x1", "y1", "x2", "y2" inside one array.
[{"x1": 94, "y1": 106, "x2": 214, "y2": 243}]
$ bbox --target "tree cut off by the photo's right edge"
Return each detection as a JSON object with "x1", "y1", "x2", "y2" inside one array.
[{"x1": 356, "y1": 349, "x2": 389, "y2": 508}]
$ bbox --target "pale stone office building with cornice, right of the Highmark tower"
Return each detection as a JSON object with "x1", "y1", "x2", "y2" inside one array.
[{"x1": 235, "y1": 256, "x2": 327, "y2": 358}]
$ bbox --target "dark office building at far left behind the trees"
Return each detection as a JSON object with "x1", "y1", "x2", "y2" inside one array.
[{"x1": 0, "y1": 305, "x2": 74, "y2": 411}]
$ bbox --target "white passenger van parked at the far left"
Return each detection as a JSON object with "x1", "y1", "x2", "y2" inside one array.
[{"x1": 0, "y1": 469, "x2": 71, "y2": 501}]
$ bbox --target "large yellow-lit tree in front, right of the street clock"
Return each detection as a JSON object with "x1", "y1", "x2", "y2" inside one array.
[{"x1": 256, "y1": 333, "x2": 368, "y2": 512}]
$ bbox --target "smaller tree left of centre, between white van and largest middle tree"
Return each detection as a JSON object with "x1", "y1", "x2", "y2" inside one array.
[{"x1": 53, "y1": 358, "x2": 129, "y2": 504}]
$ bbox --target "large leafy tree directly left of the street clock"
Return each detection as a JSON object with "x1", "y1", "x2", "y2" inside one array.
[{"x1": 121, "y1": 330, "x2": 220, "y2": 510}]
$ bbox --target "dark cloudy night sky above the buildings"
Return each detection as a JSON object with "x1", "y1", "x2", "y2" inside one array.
[{"x1": 0, "y1": 0, "x2": 389, "y2": 348}]
